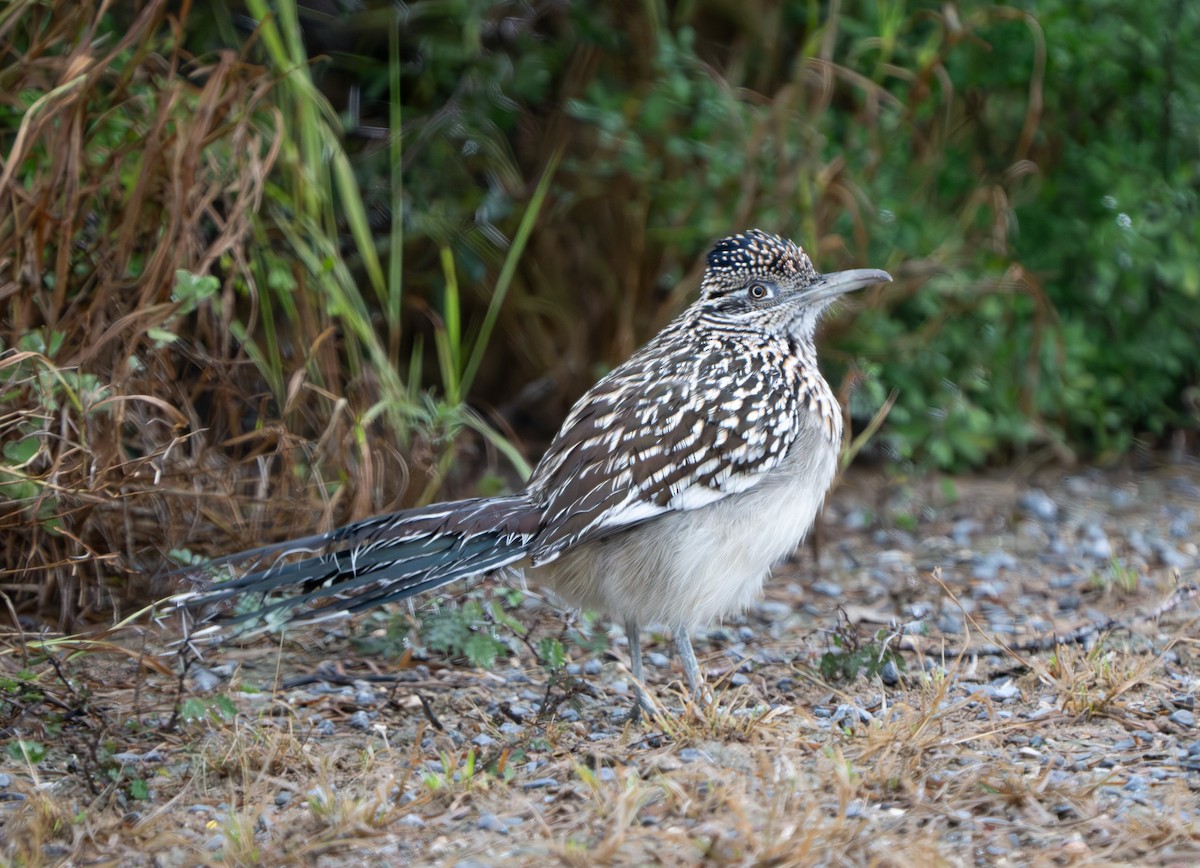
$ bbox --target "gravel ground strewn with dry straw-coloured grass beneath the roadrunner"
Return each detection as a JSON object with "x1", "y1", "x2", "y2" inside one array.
[{"x1": 0, "y1": 465, "x2": 1200, "y2": 864}]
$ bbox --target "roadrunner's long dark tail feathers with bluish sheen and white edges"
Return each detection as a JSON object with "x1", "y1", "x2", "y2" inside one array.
[{"x1": 168, "y1": 495, "x2": 538, "y2": 639}]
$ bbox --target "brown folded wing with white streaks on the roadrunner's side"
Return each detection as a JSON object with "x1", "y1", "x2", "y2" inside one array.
[{"x1": 528, "y1": 333, "x2": 804, "y2": 565}]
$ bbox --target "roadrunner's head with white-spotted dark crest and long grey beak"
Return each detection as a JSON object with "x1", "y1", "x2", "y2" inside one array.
[{"x1": 697, "y1": 229, "x2": 892, "y2": 341}]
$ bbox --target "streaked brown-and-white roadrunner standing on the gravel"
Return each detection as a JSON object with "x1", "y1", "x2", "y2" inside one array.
[{"x1": 173, "y1": 229, "x2": 892, "y2": 705}]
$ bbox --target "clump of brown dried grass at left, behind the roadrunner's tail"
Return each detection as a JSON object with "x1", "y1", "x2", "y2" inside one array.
[{"x1": 0, "y1": 0, "x2": 412, "y2": 627}]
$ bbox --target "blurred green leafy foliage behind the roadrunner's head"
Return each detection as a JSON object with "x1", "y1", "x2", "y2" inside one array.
[{"x1": 246, "y1": 0, "x2": 1200, "y2": 469}]
